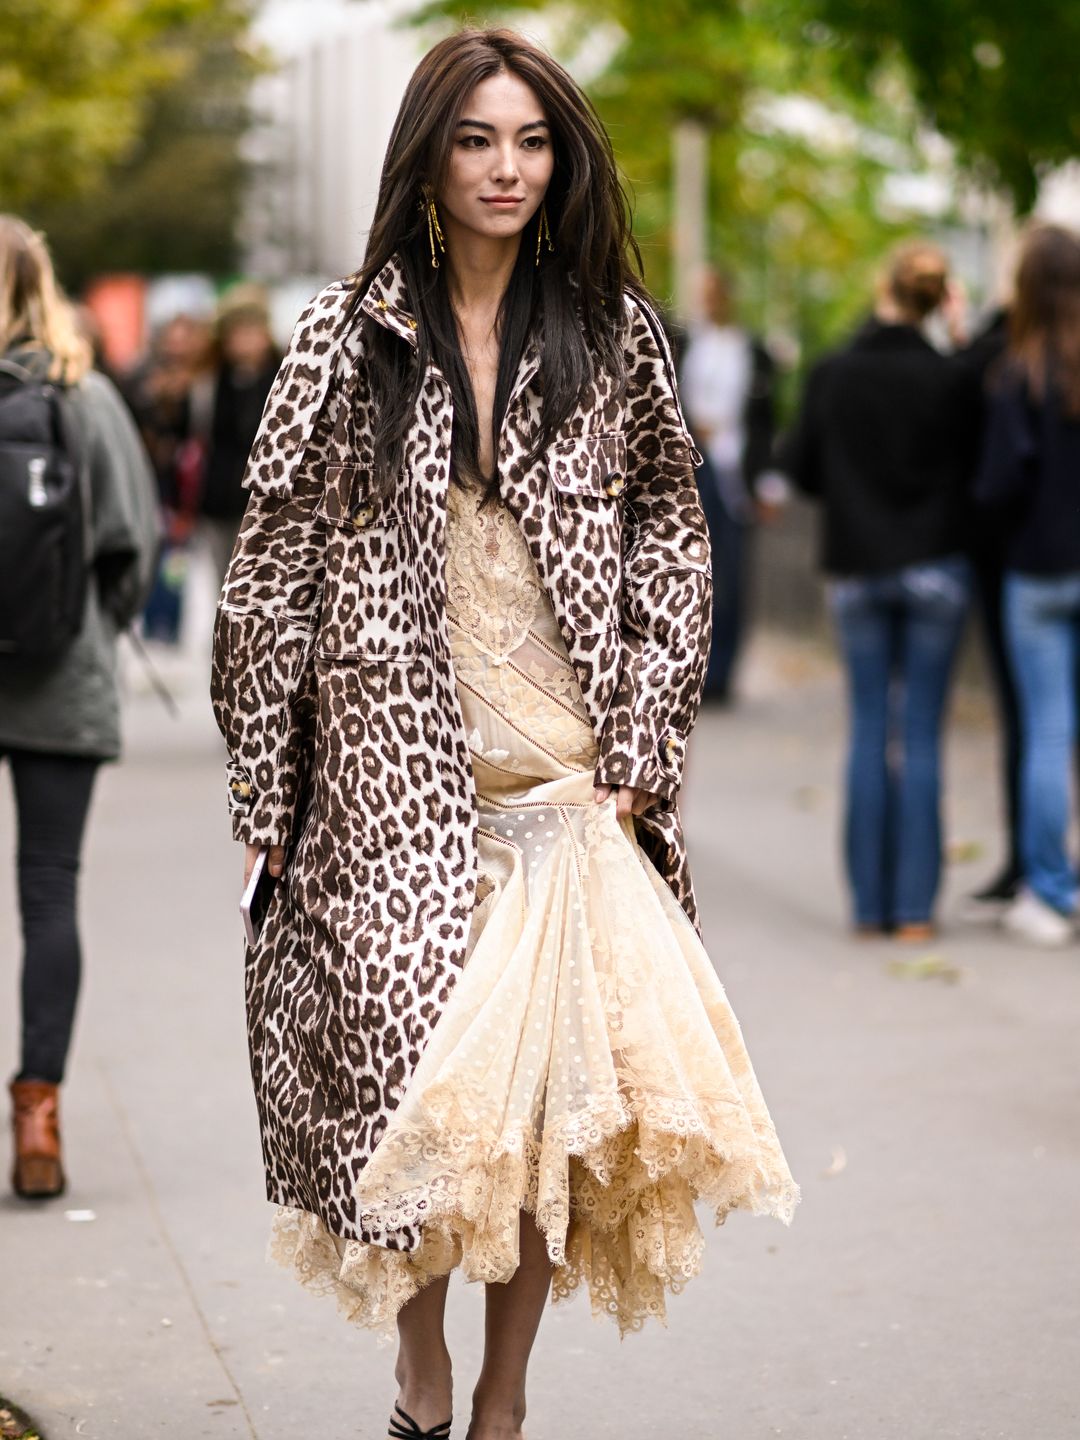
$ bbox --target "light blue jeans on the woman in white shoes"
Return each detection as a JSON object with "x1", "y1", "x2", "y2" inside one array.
[{"x1": 1004, "y1": 572, "x2": 1080, "y2": 914}]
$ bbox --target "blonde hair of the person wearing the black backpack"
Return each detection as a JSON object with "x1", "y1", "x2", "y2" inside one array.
[{"x1": 0, "y1": 215, "x2": 94, "y2": 384}]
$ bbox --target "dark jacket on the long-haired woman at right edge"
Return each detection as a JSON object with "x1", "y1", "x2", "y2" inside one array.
[{"x1": 975, "y1": 370, "x2": 1080, "y2": 575}]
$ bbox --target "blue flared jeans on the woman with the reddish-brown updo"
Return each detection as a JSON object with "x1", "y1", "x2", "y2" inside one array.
[{"x1": 829, "y1": 556, "x2": 971, "y2": 929}]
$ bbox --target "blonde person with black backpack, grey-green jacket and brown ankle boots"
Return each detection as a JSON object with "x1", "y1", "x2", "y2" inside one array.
[{"x1": 0, "y1": 215, "x2": 158, "y2": 1198}]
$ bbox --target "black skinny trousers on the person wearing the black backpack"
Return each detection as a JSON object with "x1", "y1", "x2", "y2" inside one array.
[{"x1": 0, "y1": 750, "x2": 101, "y2": 1084}]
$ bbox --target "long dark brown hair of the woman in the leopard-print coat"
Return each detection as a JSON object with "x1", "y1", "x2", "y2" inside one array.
[{"x1": 347, "y1": 30, "x2": 645, "y2": 491}]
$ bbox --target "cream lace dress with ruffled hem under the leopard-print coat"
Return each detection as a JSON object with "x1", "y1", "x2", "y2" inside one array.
[{"x1": 272, "y1": 484, "x2": 798, "y2": 1332}]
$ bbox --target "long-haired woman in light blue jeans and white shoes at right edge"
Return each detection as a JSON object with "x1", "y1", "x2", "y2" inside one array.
[{"x1": 976, "y1": 226, "x2": 1080, "y2": 945}]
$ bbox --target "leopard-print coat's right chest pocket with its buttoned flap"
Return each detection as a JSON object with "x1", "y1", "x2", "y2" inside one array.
[{"x1": 547, "y1": 435, "x2": 626, "y2": 632}]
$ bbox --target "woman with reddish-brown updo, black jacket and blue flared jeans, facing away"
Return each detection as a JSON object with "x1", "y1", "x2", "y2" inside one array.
[{"x1": 783, "y1": 243, "x2": 971, "y2": 942}]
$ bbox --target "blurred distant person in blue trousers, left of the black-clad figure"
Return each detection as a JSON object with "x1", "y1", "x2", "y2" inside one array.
[{"x1": 124, "y1": 314, "x2": 213, "y2": 645}]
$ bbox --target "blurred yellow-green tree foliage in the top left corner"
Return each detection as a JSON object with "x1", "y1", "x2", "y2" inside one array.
[{"x1": 0, "y1": 0, "x2": 259, "y2": 288}]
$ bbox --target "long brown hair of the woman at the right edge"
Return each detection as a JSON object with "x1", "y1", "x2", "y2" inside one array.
[{"x1": 1009, "y1": 225, "x2": 1080, "y2": 419}]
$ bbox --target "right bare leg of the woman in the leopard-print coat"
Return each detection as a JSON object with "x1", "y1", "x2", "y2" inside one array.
[{"x1": 467, "y1": 1211, "x2": 552, "y2": 1440}]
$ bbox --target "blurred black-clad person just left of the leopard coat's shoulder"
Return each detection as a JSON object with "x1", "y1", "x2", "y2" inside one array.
[{"x1": 199, "y1": 285, "x2": 281, "y2": 588}]
